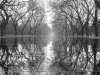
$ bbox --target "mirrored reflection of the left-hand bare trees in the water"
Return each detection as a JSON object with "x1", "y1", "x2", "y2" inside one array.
[{"x1": 0, "y1": 38, "x2": 43, "y2": 75}]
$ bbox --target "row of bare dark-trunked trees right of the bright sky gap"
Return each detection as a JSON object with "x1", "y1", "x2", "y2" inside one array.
[{"x1": 51, "y1": 0, "x2": 100, "y2": 37}]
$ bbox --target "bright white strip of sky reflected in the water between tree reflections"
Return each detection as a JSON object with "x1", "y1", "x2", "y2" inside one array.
[{"x1": 40, "y1": 41, "x2": 54, "y2": 75}]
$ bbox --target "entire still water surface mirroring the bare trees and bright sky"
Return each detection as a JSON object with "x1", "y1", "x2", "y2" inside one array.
[{"x1": 0, "y1": 36, "x2": 100, "y2": 75}]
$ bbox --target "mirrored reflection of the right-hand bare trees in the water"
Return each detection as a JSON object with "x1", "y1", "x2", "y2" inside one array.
[{"x1": 52, "y1": 38, "x2": 100, "y2": 75}]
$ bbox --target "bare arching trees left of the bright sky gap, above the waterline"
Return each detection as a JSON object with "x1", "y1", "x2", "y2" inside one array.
[{"x1": 0, "y1": 0, "x2": 44, "y2": 36}]
